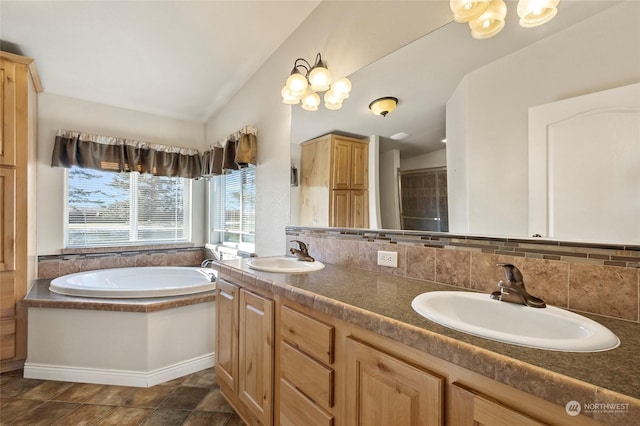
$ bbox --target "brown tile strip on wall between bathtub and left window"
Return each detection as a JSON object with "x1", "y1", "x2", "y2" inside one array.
[{"x1": 38, "y1": 245, "x2": 206, "y2": 279}]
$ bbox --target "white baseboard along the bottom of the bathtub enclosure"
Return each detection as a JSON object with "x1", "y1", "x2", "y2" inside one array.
[{"x1": 24, "y1": 353, "x2": 215, "y2": 388}]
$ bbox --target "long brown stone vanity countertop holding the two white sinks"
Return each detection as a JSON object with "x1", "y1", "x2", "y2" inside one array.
[{"x1": 216, "y1": 259, "x2": 640, "y2": 416}]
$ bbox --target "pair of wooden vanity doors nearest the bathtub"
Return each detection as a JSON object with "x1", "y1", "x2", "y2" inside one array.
[{"x1": 215, "y1": 280, "x2": 274, "y2": 425}]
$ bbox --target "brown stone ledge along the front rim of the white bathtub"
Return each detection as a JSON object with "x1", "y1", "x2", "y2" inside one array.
[{"x1": 22, "y1": 279, "x2": 216, "y2": 312}]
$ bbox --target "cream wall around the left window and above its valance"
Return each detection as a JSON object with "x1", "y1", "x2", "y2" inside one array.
[{"x1": 37, "y1": 92, "x2": 206, "y2": 255}]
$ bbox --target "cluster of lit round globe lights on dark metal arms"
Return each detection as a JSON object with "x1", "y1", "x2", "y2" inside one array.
[{"x1": 280, "y1": 53, "x2": 351, "y2": 111}]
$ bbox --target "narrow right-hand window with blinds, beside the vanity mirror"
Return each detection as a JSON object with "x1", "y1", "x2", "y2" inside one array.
[{"x1": 210, "y1": 167, "x2": 256, "y2": 253}]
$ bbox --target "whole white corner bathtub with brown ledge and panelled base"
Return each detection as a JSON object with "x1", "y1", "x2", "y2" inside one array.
[{"x1": 23, "y1": 266, "x2": 216, "y2": 387}]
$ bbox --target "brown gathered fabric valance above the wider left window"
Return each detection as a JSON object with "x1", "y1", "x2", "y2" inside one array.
[{"x1": 51, "y1": 129, "x2": 202, "y2": 178}]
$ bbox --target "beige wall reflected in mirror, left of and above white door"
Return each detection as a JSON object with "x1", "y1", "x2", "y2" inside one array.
[{"x1": 447, "y1": 2, "x2": 640, "y2": 236}]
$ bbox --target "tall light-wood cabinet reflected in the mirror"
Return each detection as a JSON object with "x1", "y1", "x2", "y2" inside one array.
[{"x1": 300, "y1": 134, "x2": 369, "y2": 228}]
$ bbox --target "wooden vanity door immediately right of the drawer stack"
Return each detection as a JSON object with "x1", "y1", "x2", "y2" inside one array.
[{"x1": 345, "y1": 339, "x2": 444, "y2": 426}]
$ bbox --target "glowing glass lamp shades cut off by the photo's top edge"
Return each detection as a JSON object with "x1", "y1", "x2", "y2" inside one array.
[{"x1": 449, "y1": 0, "x2": 560, "y2": 39}]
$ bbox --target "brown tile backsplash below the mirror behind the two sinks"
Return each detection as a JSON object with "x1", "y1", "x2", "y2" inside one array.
[{"x1": 286, "y1": 226, "x2": 640, "y2": 323}]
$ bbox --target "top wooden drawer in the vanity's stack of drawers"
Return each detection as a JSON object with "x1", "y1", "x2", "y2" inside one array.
[{"x1": 280, "y1": 306, "x2": 335, "y2": 364}]
